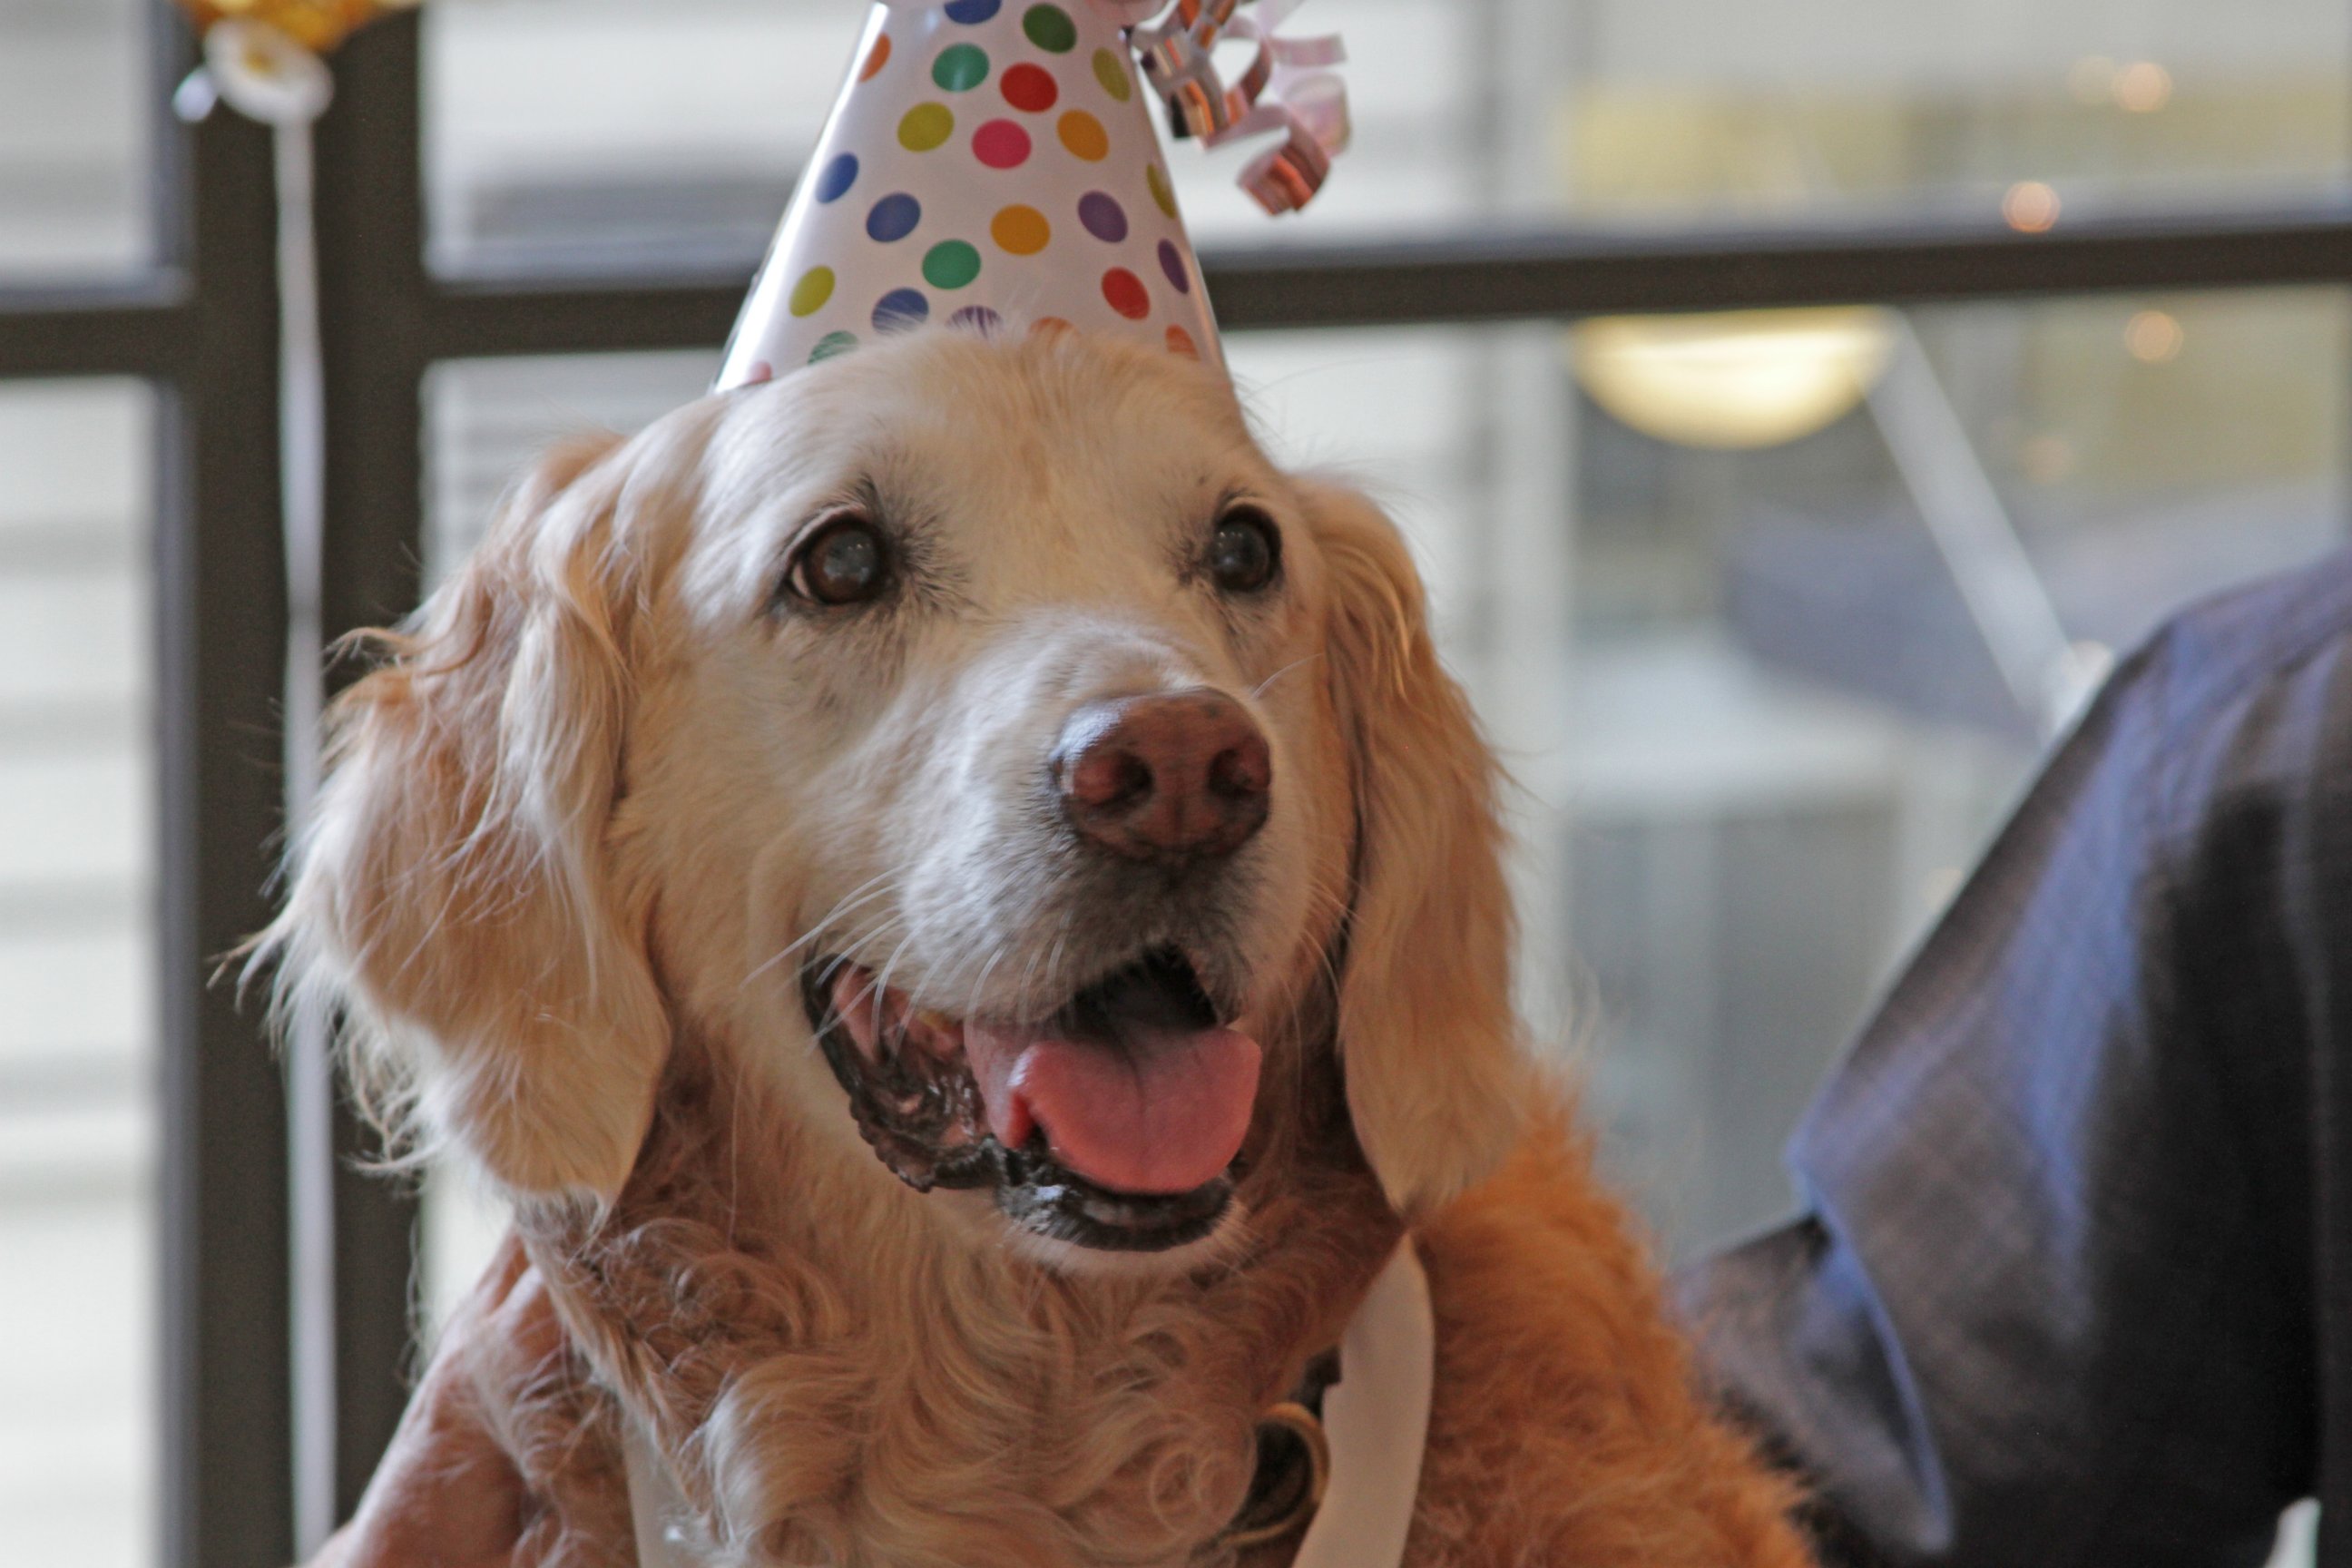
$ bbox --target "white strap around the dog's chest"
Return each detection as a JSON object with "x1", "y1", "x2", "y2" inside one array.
[{"x1": 621, "y1": 1237, "x2": 1437, "y2": 1568}]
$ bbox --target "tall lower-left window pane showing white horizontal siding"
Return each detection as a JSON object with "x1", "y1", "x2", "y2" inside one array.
[{"x1": 0, "y1": 381, "x2": 158, "y2": 1568}]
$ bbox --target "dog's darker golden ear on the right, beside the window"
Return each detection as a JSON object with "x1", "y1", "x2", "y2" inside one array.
[{"x1": 1303, "y1": 485, "x2": 1529, "y2": 1215}]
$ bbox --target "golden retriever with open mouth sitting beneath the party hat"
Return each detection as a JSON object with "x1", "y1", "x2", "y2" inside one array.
[{"x1": 266, "y1": 331, "x2": 1808, "y2": 1568}]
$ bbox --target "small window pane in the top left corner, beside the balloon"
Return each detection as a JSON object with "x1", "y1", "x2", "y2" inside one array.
[{"x1": 0, "y1": 0, "x2": 160, "y2": 284}]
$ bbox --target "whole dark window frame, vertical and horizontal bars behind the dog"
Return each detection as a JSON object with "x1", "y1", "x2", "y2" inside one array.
[{"x1": 0, "y1": 0, "x2": 2352, "y2": 1568}]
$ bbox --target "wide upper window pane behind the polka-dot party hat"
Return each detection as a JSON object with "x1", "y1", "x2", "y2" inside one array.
[{"x1": 426, "y1": 0, "x2": 2352, "y2": 263}]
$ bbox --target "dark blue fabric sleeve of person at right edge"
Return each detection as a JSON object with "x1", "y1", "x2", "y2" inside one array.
[{"x1": 1684, "y1": 554, "x2": 2352, "y2": 1568}]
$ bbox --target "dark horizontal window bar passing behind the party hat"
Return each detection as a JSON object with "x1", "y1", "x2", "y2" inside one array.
[{"x1": 404, "y1": 200, "x2": 2352, "y2": 359}]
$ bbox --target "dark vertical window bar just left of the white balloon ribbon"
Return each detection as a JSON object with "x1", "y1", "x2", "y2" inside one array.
[{"x1": 151, "y1": 5, "x2": 291, "y2": 1568}]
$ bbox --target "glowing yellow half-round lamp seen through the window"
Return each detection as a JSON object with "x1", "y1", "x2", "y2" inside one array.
[{"x1": 1569, "y1": 306, "x2": 1894, "y2": 451}]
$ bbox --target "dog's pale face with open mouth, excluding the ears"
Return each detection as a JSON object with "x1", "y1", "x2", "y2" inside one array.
[{"x1": 623, "y1": 338, "x2": 1352, "y2": 1250}]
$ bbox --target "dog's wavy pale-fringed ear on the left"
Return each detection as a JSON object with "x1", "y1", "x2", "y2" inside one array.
[{"x1": 279, "y1": 430, "x2": 668, "y2": 1197}]
